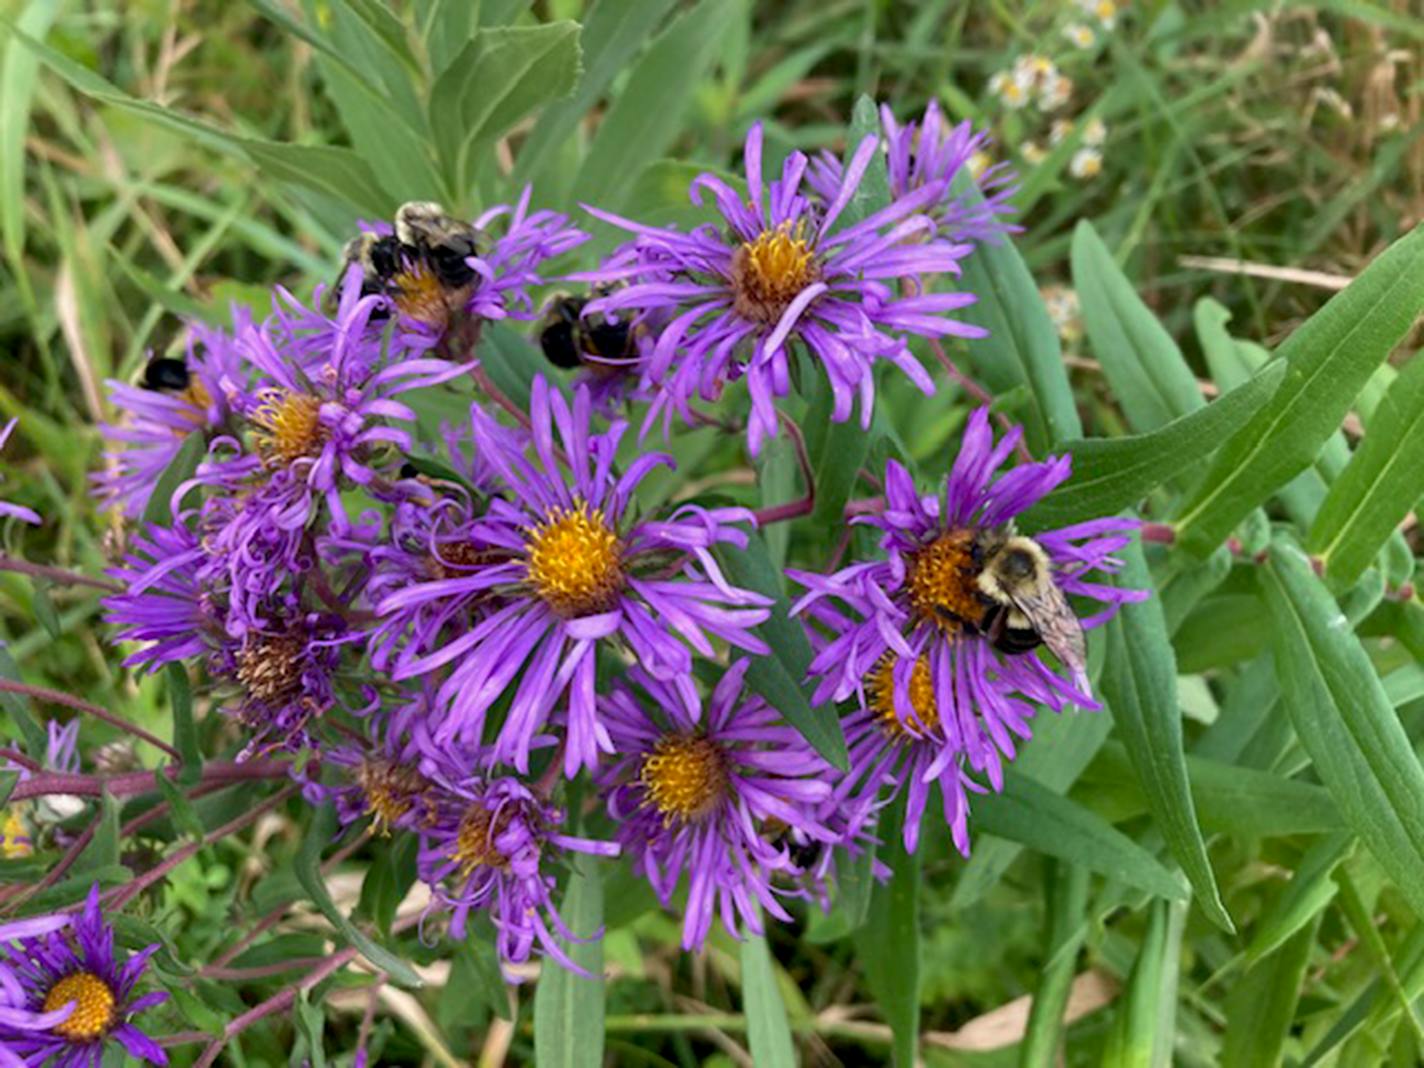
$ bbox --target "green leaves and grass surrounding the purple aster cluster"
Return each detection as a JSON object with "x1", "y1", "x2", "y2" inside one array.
[{"x1": 0, "y1": 0, "x2": 1424, "y2": 1065}]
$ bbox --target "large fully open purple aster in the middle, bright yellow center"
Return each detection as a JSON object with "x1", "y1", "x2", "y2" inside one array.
[{"x1": 377, "y1": 377, "x2": 768, "y2": 776}]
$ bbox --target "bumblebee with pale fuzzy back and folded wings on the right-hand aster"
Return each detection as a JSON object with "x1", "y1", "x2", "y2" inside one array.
[{"x1": 965, "y1": 527, "x2": 1088, "y2": 678}]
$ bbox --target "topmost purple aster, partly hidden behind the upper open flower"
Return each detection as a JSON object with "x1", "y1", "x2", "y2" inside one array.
[{"x1": 806, "y1": 100, "x2": 1020, "y2": 242}]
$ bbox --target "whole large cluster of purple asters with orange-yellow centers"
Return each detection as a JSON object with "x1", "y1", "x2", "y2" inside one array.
[{"x1": 80, "y1": 104, "x2": 1136, "y2": 1019}]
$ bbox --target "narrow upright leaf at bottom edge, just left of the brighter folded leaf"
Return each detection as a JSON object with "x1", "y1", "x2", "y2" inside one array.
[{"x1": 1018, "y1": 863, "x2": 1091, "y2": 1068}]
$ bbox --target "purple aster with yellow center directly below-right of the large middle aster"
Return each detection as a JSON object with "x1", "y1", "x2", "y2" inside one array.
[{"x1": 598, "y1": 659, "x2": 837, "y2": 950}]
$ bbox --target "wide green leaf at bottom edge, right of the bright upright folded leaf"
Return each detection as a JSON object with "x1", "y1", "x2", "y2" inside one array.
[{"x1": 1220, "y1": 911, "x2": 1320, "y2": 1068}]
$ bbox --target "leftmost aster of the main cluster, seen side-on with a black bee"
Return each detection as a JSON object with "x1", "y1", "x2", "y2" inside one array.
[{"x1": 94, "y1": 317, "x2": 249, "y2": 518}]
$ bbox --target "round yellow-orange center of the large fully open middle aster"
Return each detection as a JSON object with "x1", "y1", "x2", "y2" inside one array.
[{"x1": 524, "y1": 501, "x2": 624, "y2": 619}]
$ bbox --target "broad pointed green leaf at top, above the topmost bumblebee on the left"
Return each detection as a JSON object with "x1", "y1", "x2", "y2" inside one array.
[{"x1": 430, "y1": 21, "x2": 580, "y2": 195}]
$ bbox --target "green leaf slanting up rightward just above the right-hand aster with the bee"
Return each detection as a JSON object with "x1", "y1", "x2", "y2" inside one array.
[{"x1": 1024, "y1": 363, "x2": 1286, "y2": 530}]
